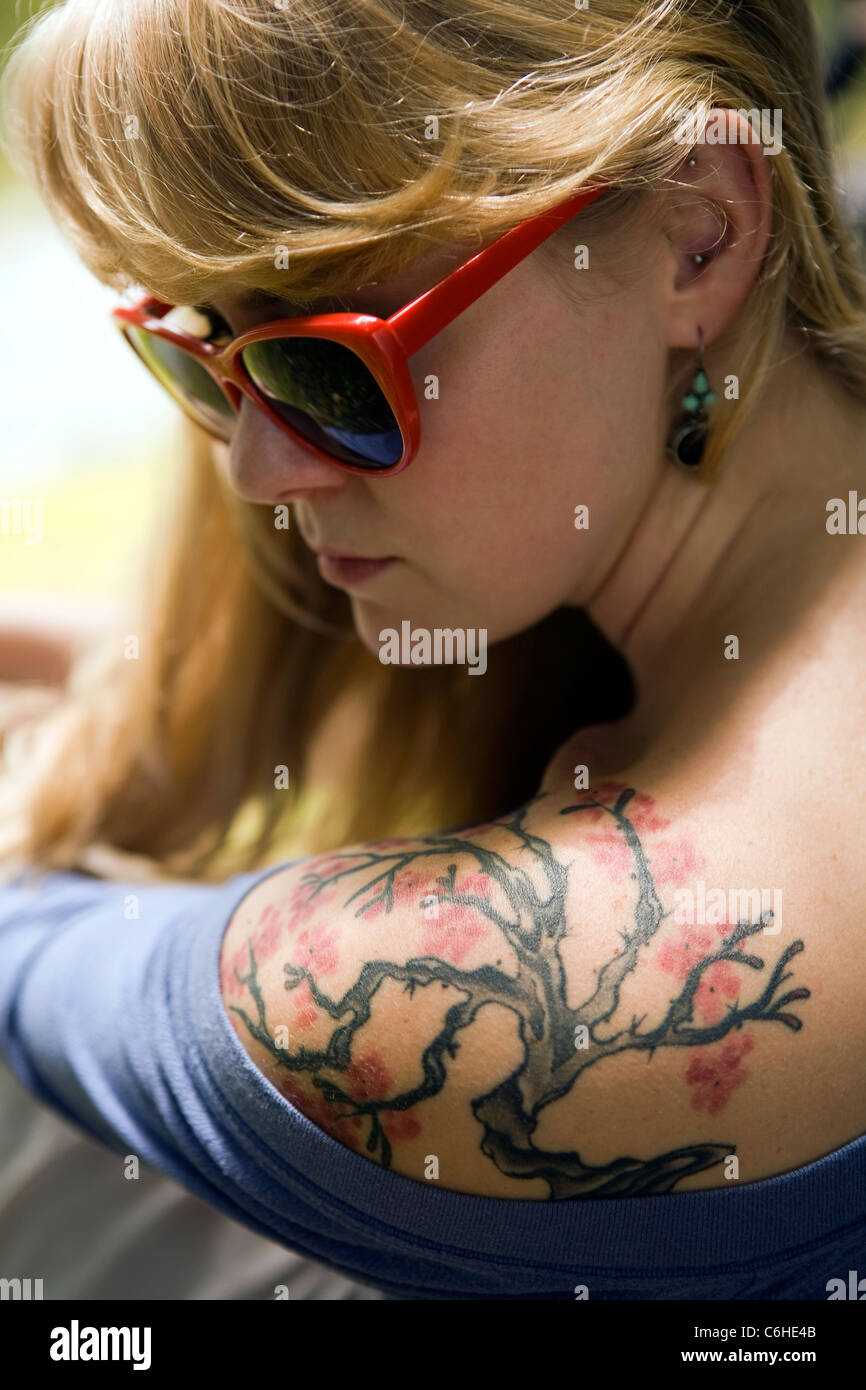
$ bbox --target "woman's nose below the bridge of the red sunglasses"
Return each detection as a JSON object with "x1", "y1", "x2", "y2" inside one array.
[{"x1": 227, "y1": 396, "x2": 349, "y2": 503}]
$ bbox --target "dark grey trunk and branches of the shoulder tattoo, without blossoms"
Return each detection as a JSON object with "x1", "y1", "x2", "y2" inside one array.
[{"x1": 231, "y1": 788, "x2": 810, "y2": 1200}]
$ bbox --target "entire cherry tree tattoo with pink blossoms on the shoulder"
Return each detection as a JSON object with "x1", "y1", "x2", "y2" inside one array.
[{"x1": 229, "y1": 784, "x2": 810, "y2": 1200}]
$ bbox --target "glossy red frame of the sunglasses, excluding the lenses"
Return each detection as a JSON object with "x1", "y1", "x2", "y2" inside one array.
[{"x1": 111, "y1": 185, "x2": 607, "y2": 478}]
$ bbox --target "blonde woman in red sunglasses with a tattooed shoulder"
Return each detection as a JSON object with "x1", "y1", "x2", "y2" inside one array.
[{"x1": 0, "y1": 0, "x2": 866, "y2": 1298}]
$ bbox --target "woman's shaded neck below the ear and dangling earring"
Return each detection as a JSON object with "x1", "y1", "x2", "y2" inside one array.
[{"x1": 558, "y1": 332, "x2": 866, "y2": 778}]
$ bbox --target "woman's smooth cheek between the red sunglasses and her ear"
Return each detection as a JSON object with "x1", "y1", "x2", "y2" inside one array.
[{"x1": 356, "y1": 290, "x2": 666, "y2": 641}]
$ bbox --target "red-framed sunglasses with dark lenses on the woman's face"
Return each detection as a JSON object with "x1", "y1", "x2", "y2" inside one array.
[{"x1": 113, "y1": 185, "x2": 606, "y2": 477}]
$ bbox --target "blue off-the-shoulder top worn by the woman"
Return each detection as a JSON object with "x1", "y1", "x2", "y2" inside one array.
[{"x1": 0, "y1": 866, "x2": 866, "y2": 1300}]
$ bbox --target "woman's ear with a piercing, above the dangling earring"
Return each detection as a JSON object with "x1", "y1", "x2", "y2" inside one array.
[{"x1": 662, "y1": 107, "x2": 773, "y2": 348}]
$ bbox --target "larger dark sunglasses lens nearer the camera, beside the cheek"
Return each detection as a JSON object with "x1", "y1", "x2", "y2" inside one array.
[{"x1": 240, "y1": 338, "x2": 403, "y2": 471}]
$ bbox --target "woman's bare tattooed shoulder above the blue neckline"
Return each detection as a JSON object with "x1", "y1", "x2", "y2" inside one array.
[{"x1": 221, "y1": 783, "x2": 866, "y2": 1198}]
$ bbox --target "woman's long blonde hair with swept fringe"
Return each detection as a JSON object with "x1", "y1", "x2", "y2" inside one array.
[{"x1": 3, "y1": 0, "x2": 866, "y2": 877}]
